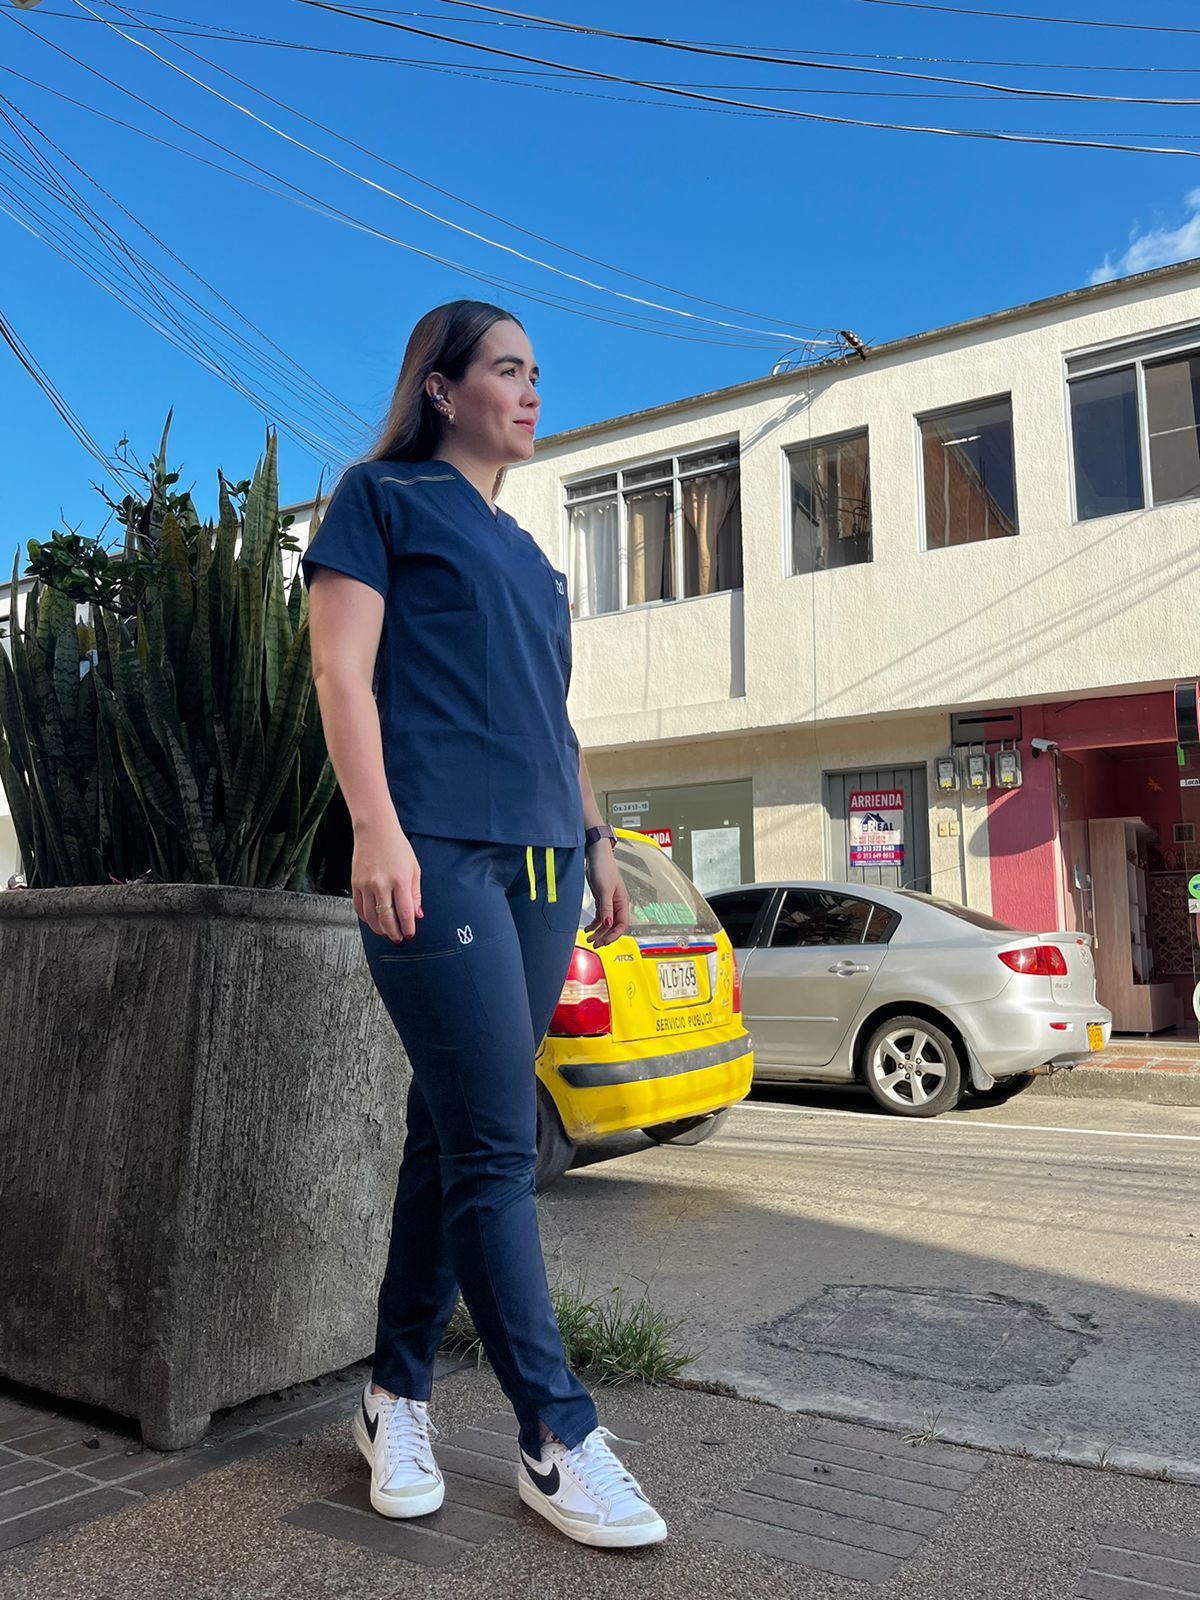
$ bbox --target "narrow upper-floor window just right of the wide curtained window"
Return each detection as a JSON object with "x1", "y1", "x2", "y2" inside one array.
[{"x1": 787, "y1": 434, "x2": 870, "y2": 573}]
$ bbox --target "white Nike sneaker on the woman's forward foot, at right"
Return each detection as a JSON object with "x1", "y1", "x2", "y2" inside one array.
[{"x1": 517, "y1": 1427, "x2": 667, "y2": 1549}]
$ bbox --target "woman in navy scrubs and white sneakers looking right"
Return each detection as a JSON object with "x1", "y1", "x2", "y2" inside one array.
[{"x1": 304, "y1": 301, "x2": 667, "y2": 1547}]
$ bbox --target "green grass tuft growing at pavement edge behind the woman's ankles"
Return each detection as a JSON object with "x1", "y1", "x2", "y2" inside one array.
[{"x1": 442, "y1": 1278, "x2": 694, "y2": 1384}]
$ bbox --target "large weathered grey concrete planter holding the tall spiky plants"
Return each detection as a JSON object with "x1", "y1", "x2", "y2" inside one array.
[{"x1": 0, "y1": 885, "x2": 408, "y2": 1450}]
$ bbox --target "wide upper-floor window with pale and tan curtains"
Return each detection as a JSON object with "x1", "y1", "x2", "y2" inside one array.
[{"x1": 566, "y1": 443, "x2": 742, "y2": 616}]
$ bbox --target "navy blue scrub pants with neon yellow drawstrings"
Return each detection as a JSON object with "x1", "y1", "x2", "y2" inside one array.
[{"x1": 360, "y1": 834, "x2": 597, "y2": 1461}]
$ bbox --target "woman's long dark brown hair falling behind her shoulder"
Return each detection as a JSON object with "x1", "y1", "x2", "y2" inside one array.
[{"x1": 365, "y1": 301, "x2": 523, "y2": 461}]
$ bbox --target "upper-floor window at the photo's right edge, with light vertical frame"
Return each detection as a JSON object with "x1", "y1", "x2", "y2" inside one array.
[{"x1": 1067, "y1": 330, "x2": 1200, "y2": 522}]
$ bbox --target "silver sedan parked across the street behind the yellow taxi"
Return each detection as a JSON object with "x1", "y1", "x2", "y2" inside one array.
[{"x1": 707, "y1": 883, "x2": 1112, "y2": 1117}]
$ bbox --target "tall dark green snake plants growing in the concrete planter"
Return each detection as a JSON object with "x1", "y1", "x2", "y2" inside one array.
[{"x1": 0, "y1": 419, "x2": 336, "y2": 890}]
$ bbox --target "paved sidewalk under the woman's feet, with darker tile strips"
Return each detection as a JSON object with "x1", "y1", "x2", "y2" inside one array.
[{"x1": 0, "y1": 1365, "x2": 1200, "y2": 1600}]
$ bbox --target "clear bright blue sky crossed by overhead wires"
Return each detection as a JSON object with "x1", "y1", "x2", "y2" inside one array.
[{"x1": 0, "y1": 0, "x2": 1200, "y2": 573}]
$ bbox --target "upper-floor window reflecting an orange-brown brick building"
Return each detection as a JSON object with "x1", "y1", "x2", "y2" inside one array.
[{"x1": 920, "y1": 397, "x2": 1016, "y2": 550}]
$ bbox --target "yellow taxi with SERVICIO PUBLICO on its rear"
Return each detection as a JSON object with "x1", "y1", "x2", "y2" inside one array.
[{"x1": 534, "y1": 827, "x2": 754, "y2": 1189}]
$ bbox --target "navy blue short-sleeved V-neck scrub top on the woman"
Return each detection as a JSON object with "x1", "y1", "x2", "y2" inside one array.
[{"x1": 302, "y1": 461, "x2": 584, "y2": 846}]
